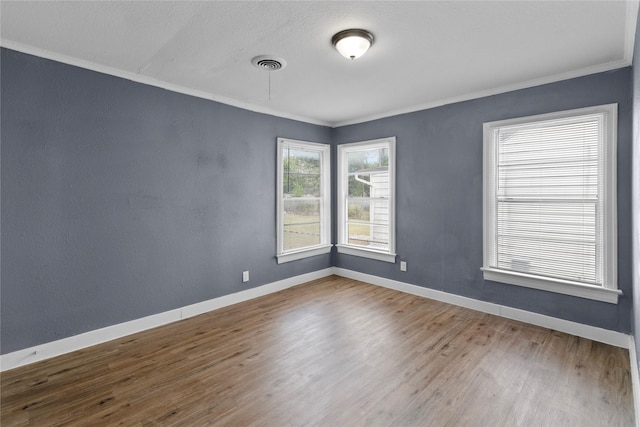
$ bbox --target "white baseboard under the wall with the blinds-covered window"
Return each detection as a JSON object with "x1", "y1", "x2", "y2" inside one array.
[{"x1": 334, "y1": 267, "x2": 629, "y2": 348}]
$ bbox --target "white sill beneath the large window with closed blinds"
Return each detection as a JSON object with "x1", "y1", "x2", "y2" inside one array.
[{"x1": 481, "y1": 267, "x2": 622, "y2": 304}]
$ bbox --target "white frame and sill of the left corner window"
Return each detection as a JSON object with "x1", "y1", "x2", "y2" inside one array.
[{"x1": 276, "y1": 138, "x2": 332, "y2": 264}]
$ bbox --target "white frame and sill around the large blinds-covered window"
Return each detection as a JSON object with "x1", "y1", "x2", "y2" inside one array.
[{"x1": 481, "y1": 104, "x2": 622, "y2": 304}]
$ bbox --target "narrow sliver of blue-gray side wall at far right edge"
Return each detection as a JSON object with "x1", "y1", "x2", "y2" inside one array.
[{"x1": 632, "y1": 6, "x2": 640, "y2": 372}]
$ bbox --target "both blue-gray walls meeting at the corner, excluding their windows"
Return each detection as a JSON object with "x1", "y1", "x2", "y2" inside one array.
[{"x1": 0, "y1": 49, "x2": 631, "y2": 354}]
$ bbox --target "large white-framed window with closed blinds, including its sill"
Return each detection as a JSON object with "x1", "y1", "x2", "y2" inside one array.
[{"x1": 482, "y1": 104, "x2": 621, "y2": 303}]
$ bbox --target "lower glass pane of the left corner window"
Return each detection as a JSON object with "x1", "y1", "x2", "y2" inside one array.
[{"x1": 283, "y1": 199, "x2": 321, "y2": 251}]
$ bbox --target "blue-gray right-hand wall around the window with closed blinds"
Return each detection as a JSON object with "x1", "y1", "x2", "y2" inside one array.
[{"x1": 332, "y1": 68, "x2": 632, "y2": 332}]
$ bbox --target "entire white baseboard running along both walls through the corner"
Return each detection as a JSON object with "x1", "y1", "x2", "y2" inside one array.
[{"x1": 0, "y1": 267, "x2": 640, "y2": 372}]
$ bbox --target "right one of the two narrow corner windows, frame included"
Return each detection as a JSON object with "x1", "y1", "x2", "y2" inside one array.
[{"x1": 337, "y1": 137, "x2": 396, "y2": 262}]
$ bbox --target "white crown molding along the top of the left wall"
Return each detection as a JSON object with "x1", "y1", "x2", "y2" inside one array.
[{"x1": 0, "y1": 38, "x2": 333, "y2": 127}]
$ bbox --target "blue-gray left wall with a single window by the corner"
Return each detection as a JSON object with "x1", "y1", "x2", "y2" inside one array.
[{"x1": 0, "y1": 49, "x2": 331, "y2": 354}]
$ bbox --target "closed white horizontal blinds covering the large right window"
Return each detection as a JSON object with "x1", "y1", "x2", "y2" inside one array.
[{"x1": 496, "y1": 115, "x2": 603, "y2": 284}]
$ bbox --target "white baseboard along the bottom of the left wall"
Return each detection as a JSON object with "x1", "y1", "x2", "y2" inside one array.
[{"x1": 0, "y1": 268, "x2": 333, "y2": 372}]
